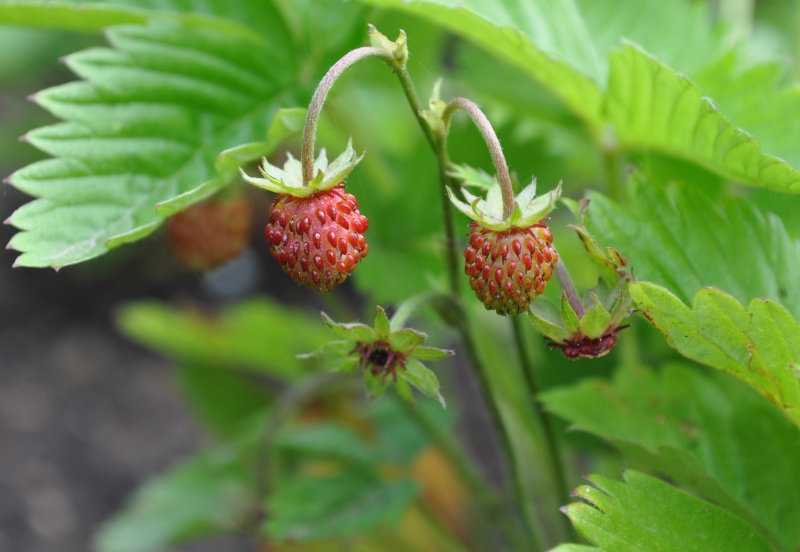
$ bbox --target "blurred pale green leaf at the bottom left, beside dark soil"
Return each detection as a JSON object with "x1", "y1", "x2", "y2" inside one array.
[{"x1": 95, "y1": 447, "x2": 256, "y2": 552}]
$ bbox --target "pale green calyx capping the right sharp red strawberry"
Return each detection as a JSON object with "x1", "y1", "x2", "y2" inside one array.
[{"x1": 447, "y1": 166, "x2": 561, "y2": 232}]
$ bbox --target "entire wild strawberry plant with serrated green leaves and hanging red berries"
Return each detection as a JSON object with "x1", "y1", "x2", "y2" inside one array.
[{"x1": 0, "y1": 0, "x2": 800, "y2": 552}]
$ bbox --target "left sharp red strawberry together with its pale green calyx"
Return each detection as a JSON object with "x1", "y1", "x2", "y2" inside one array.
[{"x1": 242, "y1": 142, "x2": 369, "y2": 293}]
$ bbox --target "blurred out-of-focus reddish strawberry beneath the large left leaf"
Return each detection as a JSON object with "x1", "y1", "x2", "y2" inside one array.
[{"x1": 167, "y1": 195, "x2": 253, "y2": 270}]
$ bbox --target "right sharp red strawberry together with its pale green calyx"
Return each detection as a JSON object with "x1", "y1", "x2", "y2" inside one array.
[{"x1": 447, "y1": 169, "x2": 561, "y2": 315}]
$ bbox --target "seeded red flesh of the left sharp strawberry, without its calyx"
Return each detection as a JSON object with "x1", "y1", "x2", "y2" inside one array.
[{"x1": 264, "y1": 183, "x2": 369, "y2": 292}]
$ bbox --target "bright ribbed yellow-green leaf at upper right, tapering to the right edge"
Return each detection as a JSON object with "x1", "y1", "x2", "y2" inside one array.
[{"x1": 606, "y1": 43, "x2": 800, "y2": 192}]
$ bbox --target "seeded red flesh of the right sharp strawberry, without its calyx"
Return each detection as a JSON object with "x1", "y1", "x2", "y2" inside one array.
[{"x1": 464, "y1": 222, "x2": 558, "y2": 314}]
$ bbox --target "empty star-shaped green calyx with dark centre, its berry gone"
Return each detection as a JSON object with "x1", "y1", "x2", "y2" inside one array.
[{"x1": 301, "y1": 307, "x2": 454, "y2": 407}]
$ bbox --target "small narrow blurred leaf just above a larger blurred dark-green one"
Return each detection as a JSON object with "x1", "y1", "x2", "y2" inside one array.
[{"x1": 274, "y1": 423, "x2": 376, "y2": 466}]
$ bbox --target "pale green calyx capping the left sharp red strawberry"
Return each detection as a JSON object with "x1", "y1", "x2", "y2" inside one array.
[{"x1": 239, "y1": 140, "x2": 364, "y2": 197}]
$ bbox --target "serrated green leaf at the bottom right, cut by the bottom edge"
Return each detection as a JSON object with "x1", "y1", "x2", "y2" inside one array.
[{"x1": 564, "y1": 470, "x2": 771, "y2": 552}]
